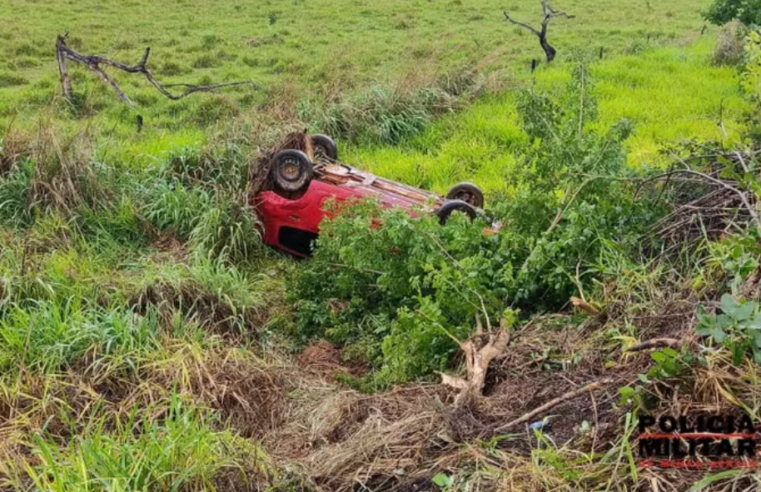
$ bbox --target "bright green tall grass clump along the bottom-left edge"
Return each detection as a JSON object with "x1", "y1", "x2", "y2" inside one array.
[{"x1": 26, "y1": 397, "x2": 267, "y2": 492}]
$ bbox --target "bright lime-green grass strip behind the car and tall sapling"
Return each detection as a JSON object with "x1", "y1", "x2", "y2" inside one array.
[{"x1": 343, "y1": 39, "x2": 750, "y2": 193}]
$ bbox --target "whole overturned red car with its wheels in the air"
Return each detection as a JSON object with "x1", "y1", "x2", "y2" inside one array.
[{"x1": 251, "y1": 135, "x2": 484, "y2": 257}]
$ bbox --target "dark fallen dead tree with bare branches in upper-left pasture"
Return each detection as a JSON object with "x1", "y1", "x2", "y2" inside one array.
[{"x1": 56, "y1": 33, "x2": 255, "y2": 125}]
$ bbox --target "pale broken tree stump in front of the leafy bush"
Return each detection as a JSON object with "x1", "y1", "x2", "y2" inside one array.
[{"x1": 439, "y1": 316, "x2": 510, "y2": 406}]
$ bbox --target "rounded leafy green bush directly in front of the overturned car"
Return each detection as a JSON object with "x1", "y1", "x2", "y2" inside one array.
[{"x1": 288, "y1": 202, "x2": 514, "y2": 382}]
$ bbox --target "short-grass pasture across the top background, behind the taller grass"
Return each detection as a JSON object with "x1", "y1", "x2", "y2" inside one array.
[{"x1": 0, "y1": 0, "x2": 709, "y2": 138}]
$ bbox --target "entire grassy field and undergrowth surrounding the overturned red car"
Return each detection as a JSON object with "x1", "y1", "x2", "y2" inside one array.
[{"x1": 0, "y1": 0, "x2": 761, "y2": 492}]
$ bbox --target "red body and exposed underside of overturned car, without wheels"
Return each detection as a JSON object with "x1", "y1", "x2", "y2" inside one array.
[{"x1": 252, "y1": 163, "x2": 445, "y2": 257}]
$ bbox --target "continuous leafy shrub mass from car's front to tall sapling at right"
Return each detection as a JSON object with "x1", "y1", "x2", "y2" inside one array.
[{"x1": 289, "y1": 58, "x2": 660, "y2": 385}]
